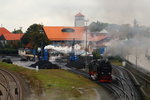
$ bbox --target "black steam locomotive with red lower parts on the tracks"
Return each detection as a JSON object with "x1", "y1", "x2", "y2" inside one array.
[{"x1": 88, "y1": 59, "x2": 112, "y2": 82}]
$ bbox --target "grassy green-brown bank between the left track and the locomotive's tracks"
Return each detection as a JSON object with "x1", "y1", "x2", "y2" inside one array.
[{"x1": 0, "y1": 63, "x2": 98, "y2": 100}]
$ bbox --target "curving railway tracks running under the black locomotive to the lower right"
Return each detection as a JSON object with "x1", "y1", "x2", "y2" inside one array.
[{"x1": 69, "y1": 69, "x2": 137, "y2": 100}]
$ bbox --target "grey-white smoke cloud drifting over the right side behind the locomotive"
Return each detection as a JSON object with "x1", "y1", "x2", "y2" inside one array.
[{"x1": 105, "y1": 24, "x2": 150, "y2": 71}]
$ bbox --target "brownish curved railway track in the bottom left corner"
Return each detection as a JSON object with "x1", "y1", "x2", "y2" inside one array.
[{"x1": 0, "y1": 69, "x2": 22, "y2": 100}]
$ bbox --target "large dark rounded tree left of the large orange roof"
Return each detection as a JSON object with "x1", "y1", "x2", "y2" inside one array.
[{"x1": 22, "y1": 24, "x2": 49, "y2": 48}]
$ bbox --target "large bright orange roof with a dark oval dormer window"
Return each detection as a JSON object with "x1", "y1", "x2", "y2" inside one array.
[{"x1": 43, "y1": 26, "x2": 85, "y2": 41}]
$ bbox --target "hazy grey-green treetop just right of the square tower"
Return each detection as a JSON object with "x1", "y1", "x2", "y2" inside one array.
[{"x1": 88, "y1": 21, "x2": 108, "y2": 32}]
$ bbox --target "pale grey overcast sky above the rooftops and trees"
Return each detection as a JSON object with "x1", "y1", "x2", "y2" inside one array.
[{"x1": 0, "y1": 0, "x2": 150, "y2": 31}]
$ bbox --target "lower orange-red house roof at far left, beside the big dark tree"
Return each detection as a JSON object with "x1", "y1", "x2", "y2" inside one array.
[{"x1": 3, "y1": 33, "x2": 24, "y2": 40}]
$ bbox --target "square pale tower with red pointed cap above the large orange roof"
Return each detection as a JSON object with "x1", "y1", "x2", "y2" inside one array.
[{"x1": 74, "y1": 13, "x2": 85, "y2": 27}]
